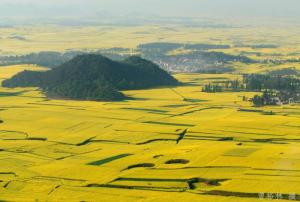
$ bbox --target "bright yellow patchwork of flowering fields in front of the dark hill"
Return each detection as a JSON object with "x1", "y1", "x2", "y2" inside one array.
[{"x1": 0, "y1": 65, "x2": 300, "y2": 202}]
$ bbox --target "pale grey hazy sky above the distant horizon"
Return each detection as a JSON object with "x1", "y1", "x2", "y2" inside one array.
[{"x1": 0, "y1": 0, "x2": 300, "y2": 18}]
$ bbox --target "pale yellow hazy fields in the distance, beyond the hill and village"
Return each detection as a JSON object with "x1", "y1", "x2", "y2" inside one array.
[{"x1": 0, "y1": 25, "x2": 300, "y2": 59}]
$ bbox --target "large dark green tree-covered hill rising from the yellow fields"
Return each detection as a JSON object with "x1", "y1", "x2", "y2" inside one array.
[{"x1": 2, "y1": 54, "x2": 179, "y2": 101}]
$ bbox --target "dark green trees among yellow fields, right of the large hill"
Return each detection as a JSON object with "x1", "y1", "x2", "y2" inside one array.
[{"x1": 202, "y1": 74, "x2": 300, "y2": 106}]
